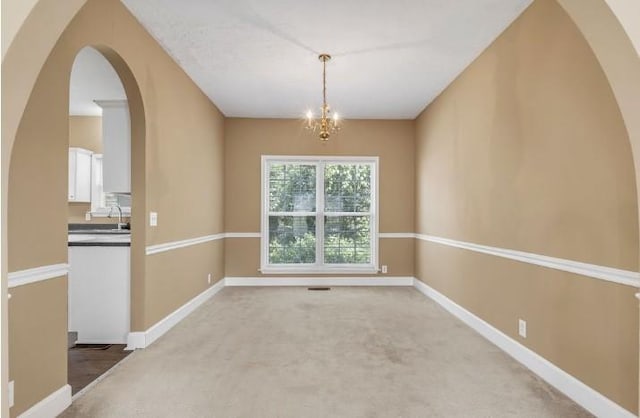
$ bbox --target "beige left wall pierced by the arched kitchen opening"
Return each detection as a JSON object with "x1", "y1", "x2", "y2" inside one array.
[{"x1": 3, "y1": 0, "x2": 224, "y2": 416}]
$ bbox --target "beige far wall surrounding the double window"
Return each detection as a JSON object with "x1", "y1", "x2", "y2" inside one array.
[{"x1": 224, "y1": 118, "x2": 415, "y2": 276}]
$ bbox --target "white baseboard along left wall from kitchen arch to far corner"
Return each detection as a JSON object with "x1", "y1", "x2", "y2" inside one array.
[{"x1": 125, "y1": 279, "x2": 225, "y2": 350}]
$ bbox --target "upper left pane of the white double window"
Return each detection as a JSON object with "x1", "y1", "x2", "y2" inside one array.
[{"x1": 269, "y1": 164, "x2": 316, "y2": 212}]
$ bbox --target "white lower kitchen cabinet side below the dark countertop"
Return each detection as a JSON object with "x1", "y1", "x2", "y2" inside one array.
[{"x1": 69, "y1": 246, "x2": 131, "y2": 344}]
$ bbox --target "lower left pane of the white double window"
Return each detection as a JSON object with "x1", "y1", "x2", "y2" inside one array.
[{"x1": 269, "y1": 216, "x2": 316, "y2": 264}]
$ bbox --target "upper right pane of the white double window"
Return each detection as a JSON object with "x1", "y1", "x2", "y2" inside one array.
[{"x1": 324, "y1": 164, "x2": 371, "y2": 212}]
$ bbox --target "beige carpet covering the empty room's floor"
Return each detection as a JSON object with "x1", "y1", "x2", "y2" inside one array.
[{"x1": 62, "y1": 288, "x2": 590, "y2": 417}]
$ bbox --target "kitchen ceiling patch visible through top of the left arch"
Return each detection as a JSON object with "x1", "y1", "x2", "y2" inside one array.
[{"x1": 69, "y1": 47, "x2": 127, "y2": 116}]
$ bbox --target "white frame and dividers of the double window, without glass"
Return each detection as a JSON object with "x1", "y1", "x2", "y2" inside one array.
[{"x1": 260, "y1": 155, "x2": 379, "y2": 274}]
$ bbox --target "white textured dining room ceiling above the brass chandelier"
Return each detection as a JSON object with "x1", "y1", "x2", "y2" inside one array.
[{"x1": 114, "y1": 0, "x2": 531, "y2": 119}]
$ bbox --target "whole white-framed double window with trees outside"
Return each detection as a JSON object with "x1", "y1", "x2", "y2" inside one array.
[{"x1": 261, "y1": 156, "x2": 378, "y2": 273}]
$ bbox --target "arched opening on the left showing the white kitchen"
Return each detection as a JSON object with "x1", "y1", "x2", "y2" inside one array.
[{"x1": 67, "y1": 47, "x2": 135, "y2": 396}]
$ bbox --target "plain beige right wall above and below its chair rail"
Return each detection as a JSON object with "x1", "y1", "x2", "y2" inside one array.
[{"x1": 416, "y1": 0, "x2": 638, "y2": 411}]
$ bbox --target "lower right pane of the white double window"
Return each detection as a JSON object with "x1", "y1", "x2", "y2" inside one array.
[{"x1": 324, "y1": 216, "x2": 371, "y2": 264}]
